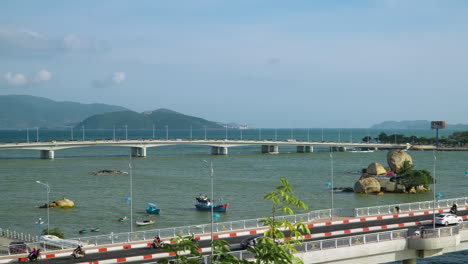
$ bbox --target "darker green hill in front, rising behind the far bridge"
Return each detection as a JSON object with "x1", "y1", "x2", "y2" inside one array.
[{"x1": 77, "y1": 108, "x2": 223, "y2": 129}]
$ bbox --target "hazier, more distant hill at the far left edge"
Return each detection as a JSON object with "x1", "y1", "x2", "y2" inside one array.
[{"x1": 0, "y1": 95, "x2": 128, "y2": 129}]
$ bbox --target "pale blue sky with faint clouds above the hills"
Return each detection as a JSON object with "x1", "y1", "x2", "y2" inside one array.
[{"x1": 0, "y1": 0, "x2": 468, "y2": 128}]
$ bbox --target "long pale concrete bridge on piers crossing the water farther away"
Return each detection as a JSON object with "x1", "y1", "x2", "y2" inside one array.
[{"x1": 0, "y1": 139, "x2": 411, "y2": 159}]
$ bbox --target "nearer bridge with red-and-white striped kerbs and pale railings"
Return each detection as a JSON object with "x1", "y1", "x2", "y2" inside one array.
[{"x1": 0, "y1": 197, "x2": 468, "y2": 264}]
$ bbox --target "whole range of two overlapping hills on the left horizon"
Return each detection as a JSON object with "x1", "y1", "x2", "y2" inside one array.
[{"x1": 0, "y1": 95, "x2": 223, "y2": 129}]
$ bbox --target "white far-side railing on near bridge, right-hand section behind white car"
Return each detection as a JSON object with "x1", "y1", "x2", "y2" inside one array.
[{"x1": 354, "y1": 197, "x2": 468, "y2": 217}]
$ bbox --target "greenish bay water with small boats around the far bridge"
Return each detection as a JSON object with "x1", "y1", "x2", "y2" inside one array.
[{"x1": 0, "y1": 129, "x2": 468, "y2": 263}]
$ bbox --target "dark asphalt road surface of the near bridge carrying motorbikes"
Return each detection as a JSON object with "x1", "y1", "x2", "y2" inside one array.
[{"x1": 30, "y1": 210, "x2": 468, "y2": 264}]
